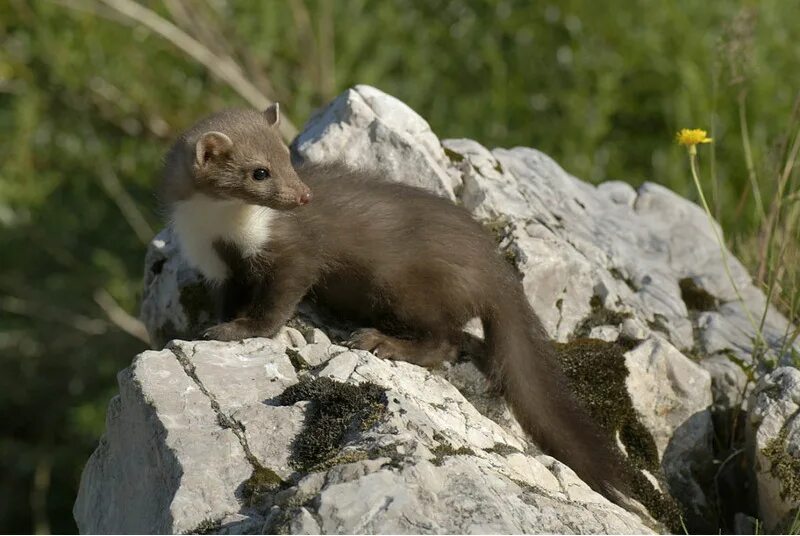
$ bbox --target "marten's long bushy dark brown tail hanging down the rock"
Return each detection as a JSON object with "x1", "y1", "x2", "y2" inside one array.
[{"x1": 482, "y1": 285, "x2": 628, "y2": 502}]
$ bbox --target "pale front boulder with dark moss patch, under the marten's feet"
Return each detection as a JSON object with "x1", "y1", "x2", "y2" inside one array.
[{"x1": 75, "y1": 338, "x2": 649, "y2": 533}]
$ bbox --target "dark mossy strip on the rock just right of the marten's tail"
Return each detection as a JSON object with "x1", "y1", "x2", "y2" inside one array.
[{"x1": 556, "y1": 338, "x2": 680, "y2": 530}]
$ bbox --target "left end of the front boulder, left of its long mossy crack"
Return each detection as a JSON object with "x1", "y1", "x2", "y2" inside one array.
[{"x1": 74, "y1": 350, "x2": 252, "y2": 534}]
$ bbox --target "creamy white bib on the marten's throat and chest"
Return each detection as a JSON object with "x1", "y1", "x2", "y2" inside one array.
[{"x1": 172, "y1": 194, "x2": 275, "y2": 283}]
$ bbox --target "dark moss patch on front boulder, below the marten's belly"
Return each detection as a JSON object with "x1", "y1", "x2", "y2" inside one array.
[{"x1": 278, "y1": 378, "x2": 387, "y2": 471}]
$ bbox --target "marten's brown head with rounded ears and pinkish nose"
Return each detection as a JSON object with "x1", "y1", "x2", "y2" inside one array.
[{"x1": 165, "y1": 103, "x2": 311, "y2": 210}]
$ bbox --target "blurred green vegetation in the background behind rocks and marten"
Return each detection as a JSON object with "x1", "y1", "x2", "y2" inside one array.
[{"x1": 0, "y1": 0, "x2": 800, "y2": 532}]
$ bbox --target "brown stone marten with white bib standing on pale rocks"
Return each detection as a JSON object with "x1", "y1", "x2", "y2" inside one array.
[{"x1": 162, "y1": 105, "x2": 628, "y2": 501}]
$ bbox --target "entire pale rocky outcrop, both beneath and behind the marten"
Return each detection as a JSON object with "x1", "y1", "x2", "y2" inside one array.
[{"x1": 75, "y1": 86, "x2": 790, "y2": 533}]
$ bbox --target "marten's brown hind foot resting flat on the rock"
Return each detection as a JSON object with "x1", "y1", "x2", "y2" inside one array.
[{"x1": 348, "y1": 329, "x2": 459, "y2": 367}]
